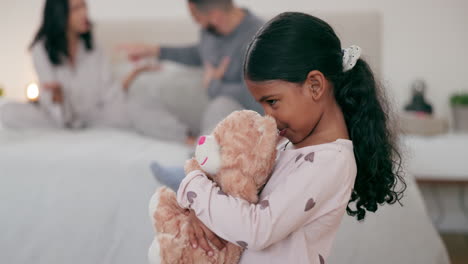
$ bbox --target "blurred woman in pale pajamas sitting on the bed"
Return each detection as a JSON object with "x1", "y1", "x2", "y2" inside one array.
[{"x1": 2, "y1": 0, "x2": 186, "y2": 141}]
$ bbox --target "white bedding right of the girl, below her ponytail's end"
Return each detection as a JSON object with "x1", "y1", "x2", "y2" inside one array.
[{"x1": 328, "y1": 176, "x2": 450, "y2": 264}]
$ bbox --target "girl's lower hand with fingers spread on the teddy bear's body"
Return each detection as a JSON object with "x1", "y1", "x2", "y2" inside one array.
[{"x1": 187, "y1": 211, "x2": 227, "y2": 257}]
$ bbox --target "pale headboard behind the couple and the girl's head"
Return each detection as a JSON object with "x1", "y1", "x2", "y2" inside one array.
[{"x1": 95, "y1": 12, "x2": 382, "y2": 76}]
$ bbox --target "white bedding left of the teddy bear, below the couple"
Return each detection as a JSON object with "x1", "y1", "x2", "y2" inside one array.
[{"x1": 0, "y1": 130, "x2": 188, "y2": 264}]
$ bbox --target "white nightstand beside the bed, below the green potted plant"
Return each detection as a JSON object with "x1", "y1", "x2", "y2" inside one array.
[{"x1": 401, "y1": 133, "x2": 468, "y2": 232}]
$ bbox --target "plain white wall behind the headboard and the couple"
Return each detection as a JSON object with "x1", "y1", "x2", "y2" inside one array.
[{"x1": 0, "y1": 0, "x2": 468, "y2": 117}]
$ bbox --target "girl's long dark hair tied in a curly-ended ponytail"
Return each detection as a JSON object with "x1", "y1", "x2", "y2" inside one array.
[{"x1": 244, "y1": 12, "x2": 406, "y2": 220}]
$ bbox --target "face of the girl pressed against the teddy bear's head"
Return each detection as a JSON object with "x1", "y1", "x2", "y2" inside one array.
[{"x1": 246, "y1": 80, "x2": 323, "y2": 147}]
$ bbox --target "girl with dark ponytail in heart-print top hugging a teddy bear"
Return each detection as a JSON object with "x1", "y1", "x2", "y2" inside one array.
[{"x1": 177, "y1": 13, "x2": 405, "y2": 263}]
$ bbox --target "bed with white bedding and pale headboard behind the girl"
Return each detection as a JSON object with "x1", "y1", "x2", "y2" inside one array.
[{"x1": 0, "y1": 10, "x2": 449, "y2": 264}]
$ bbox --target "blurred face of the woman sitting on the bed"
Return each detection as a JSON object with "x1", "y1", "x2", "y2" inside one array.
[{"x1": 68, "y1": 0, "x2": 90, "y2": 34}]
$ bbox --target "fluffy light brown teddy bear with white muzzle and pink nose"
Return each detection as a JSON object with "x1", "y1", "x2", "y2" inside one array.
[{"x1": 149, "y1": 110, "x2": 279, "y2": 264}]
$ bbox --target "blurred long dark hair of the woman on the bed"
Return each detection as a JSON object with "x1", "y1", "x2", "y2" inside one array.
[{"x1": 30, "y1": 0, "x2": 93, "y2": 65}]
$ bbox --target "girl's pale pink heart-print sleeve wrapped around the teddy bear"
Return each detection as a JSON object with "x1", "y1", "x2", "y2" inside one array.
[{"x1": 177, "y1": 150, "x2": 354, "y2": 250}]
